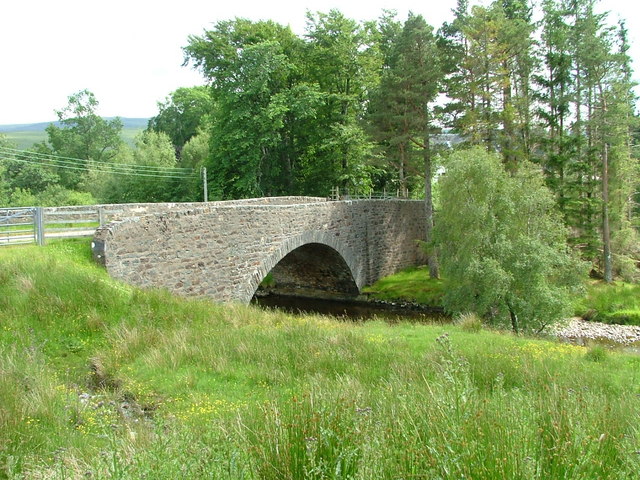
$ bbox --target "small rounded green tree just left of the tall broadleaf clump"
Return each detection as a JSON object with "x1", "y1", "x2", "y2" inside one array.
[{"x1": 148, "y1": 86, "x2": 213, "y2": 158}]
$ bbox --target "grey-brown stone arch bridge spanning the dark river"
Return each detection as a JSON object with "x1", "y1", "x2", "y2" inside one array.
[{"x1": 92, "y1": 197, "x2": 425, "y2": 303}]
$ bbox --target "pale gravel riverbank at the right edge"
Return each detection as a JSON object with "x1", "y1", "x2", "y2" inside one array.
[{"x1": 552, "y1": 317, "x2": 640, "y2": 345}]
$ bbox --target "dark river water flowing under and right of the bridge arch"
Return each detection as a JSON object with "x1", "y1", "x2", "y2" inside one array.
[{"x1": 251, "y1": 294, "x2": 450, "y2": 323}]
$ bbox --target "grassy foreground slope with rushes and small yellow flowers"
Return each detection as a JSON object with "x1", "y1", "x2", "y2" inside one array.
[{"x1": 0, "y1": 242, "x2": 640, "y2": 479}]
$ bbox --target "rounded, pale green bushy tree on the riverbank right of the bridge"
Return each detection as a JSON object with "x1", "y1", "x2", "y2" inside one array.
[{"x1": 434, "y1": 147, "x2": 583, "y2": 332}]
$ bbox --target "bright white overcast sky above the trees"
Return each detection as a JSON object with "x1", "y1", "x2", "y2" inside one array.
[{"x1": 0, "y1": 0, "x2": 640, "y2": 125}]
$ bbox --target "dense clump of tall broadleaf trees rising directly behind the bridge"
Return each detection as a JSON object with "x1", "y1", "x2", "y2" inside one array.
[{"x1": 185, "y1": 11, "x2": 377, "y2": 198}]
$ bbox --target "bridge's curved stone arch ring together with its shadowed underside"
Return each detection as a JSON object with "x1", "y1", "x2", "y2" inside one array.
[{"x1": 251, "y1": 232, "x2": 364, "y2": 297}]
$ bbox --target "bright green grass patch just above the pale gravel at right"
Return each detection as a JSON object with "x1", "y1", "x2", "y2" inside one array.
[{"x1": 576, "y1": 281, "x2": 640, "y2": 325}]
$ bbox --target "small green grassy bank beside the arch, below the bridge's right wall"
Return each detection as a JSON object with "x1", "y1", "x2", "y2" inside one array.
[{"x1": 363, "y1": 267, "x2": 444, "y2": 307}]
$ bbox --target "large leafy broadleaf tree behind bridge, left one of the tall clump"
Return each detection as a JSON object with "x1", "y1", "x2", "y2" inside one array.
[{"x1": 185, "y1": 19, "x2": 321, "y2": 198}]
